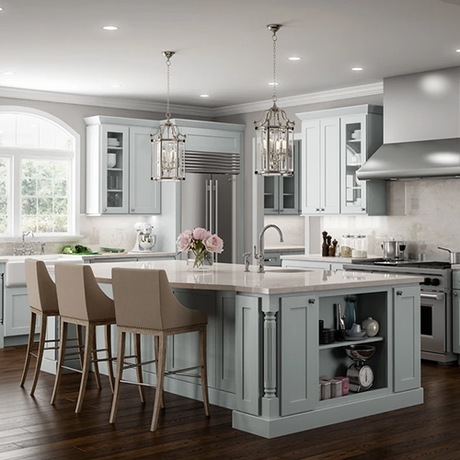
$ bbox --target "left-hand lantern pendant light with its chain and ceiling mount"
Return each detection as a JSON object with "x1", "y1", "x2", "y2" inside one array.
[{"x1": 151, "y1": 51, "x2": 185, "y2": 181}]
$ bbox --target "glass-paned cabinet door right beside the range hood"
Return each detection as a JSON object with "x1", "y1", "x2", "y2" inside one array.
[{"x1": 340, "y1": 115, "x2": 367, "y2": 214}]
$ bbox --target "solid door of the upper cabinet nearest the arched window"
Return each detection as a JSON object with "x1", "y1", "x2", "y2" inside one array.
[{"x1": 129, "y1": 127, "x2": 161, "y2": 215}]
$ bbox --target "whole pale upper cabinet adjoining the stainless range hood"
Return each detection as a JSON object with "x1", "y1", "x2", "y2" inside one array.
[{"x1": 297, "y1": 105, "x2": 386, "y2": 215}]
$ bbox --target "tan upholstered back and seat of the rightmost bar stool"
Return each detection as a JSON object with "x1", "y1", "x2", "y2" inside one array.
[{"x1": 112, "y1": 268, "x2": 207, "y2": 330}]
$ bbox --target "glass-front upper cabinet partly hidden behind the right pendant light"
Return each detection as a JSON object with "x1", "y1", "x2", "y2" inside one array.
[{"x1": 264, "y1": 141, "x2": 301, "y2": 215}]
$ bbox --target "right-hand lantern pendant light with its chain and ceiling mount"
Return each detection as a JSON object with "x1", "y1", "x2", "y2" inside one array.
[{"x1": 254, "y1": 24, "x2": 295, "y2": 176}]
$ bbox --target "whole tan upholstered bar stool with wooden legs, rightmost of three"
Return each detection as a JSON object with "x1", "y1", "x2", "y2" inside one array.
[{"x1": 109, "y1": 268, "x2": 209, "y2": 431}]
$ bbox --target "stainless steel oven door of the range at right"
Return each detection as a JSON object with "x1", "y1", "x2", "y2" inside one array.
[{"x1": 420, "y1": 291, "x2": 447, "y2": 353}]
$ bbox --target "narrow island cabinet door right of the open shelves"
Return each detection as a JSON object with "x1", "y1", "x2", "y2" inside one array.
[{"x1": 393, "y1": 286, "x2": 421, "y2": 392}]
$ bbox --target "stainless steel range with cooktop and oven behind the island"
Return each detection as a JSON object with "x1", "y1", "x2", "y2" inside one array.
[{"x1": 344, "y1": 259, "x2": 457, "y2": 363}]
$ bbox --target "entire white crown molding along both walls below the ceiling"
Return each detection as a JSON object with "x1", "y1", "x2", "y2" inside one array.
[{"x1": 0, "y1": 82, "x2": 383, "y2": 118}]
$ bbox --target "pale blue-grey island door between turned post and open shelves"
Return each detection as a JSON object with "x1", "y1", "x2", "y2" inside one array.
[{"x1": 280, "y1": 295, "x2": 319, "y2": 416}]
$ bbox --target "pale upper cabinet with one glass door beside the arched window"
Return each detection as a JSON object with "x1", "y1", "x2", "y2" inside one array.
[{"x1": 85, "y1": 116, "x2": 161, "y2": 215}]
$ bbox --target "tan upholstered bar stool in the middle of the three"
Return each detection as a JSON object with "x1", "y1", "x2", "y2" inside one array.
[{"x1": 51, "y1": 263, "x2": 115, "y2": 413}]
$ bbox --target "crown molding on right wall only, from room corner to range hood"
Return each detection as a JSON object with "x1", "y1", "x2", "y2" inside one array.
[{"x1": 212, "y1": 82, "x2": 383, "y2": 117}]
